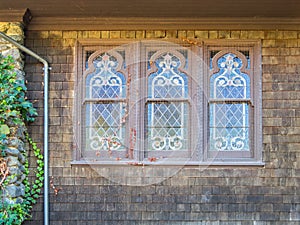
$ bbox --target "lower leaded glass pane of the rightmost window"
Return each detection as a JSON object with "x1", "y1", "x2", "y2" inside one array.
[{"x1": 210, "y1": 103, "x2": 249, "y2": 151}]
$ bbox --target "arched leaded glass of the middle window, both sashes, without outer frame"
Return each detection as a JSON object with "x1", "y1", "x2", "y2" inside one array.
[{"x1": 147, "y1": 53, "x2": 188, "y2": 151}]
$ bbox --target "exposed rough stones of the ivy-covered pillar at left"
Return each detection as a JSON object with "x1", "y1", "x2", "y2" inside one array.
[{"x1": 0, "y1": 22, "x2": 26, "y2": 203}]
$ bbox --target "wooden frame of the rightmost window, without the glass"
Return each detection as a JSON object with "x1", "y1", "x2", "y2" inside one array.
[{"x1": 203, "y1": 39, "x2": 263, "y2": 165}]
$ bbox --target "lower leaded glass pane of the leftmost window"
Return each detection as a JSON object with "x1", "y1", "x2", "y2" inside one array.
[{"x1": 86, "y1": 103, "x2": 125, "y2": 150}]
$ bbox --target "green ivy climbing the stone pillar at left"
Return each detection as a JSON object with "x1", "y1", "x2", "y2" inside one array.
[{"x1": 0, "y1": 54, "x2": 44, "y2": 225}]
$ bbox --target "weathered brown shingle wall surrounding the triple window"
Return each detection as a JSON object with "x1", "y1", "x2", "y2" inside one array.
[{"x1": 25, "y1": 30, "x2": 300, "y2": 225}]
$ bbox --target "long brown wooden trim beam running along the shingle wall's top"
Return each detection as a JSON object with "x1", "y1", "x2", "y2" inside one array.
[{"x1": 28, "y1": 17, "x2": 300, "y2": 30}]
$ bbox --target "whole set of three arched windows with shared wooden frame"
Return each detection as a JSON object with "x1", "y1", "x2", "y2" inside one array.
[{"x1": 74, "y1": 40, "x2": 262, "y2": 165}]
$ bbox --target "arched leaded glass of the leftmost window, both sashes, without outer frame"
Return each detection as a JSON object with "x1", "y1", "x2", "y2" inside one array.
[{"x1": 85, "y1": 53, "x2": 126, "y2": 151}]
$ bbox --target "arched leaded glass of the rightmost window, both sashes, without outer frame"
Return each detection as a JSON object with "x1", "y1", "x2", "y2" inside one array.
[{"x1": 209, "y1": 53, "x2": 250, "y2": 151}]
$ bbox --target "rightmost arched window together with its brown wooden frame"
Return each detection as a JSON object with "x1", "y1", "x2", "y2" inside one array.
[{"x1": 205, "y1": 43, "x2": 261, "y2": 162}]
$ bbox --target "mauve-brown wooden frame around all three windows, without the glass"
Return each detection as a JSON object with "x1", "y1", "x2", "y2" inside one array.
[{"x1": 71, "y1": 39, "x2": 264, "y2": 166}]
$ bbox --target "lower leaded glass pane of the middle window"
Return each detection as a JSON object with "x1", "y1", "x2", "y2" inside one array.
[{"x1": 147, "y1": 103, "x2": 188, "y2": 150}]
